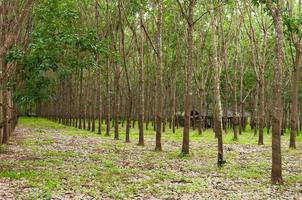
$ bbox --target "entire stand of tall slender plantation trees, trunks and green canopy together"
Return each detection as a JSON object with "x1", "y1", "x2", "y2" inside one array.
[{"x1": 0, "y1": 0, "x2": 302, "y2": 183}]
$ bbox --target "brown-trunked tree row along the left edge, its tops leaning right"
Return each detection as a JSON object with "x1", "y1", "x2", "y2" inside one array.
[{"x1": 0, "y1": 0, "x2": 32, "y2": 145}]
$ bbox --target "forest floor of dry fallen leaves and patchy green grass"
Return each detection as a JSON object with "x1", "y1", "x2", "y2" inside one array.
[{"x1": 0, "y1": 118, "x2": 302, "y2": 200}]
